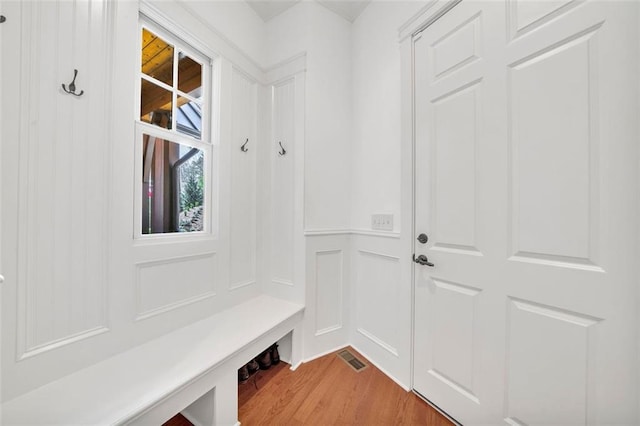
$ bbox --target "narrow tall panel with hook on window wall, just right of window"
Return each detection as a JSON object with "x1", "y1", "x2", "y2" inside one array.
[{"x1": 229, "y1": 69, "x2": 258, "y2": 289}]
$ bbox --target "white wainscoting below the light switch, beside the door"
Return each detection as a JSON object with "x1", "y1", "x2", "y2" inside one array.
[{"x1": 348, "y1": 231, "x2": 412, "y2": 390}]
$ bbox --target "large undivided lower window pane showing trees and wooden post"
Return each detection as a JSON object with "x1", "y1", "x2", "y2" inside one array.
[{"x1": 141, "y1": 135, "x2": 205, "y2": 234}]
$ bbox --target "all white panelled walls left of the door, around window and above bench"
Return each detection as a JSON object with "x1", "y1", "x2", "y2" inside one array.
[{"x1": 0, "y1": 0, "x2": 430, "y2": 400}]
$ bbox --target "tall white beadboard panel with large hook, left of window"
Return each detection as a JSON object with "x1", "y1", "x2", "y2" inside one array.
[{"x1": 10, "y1": 1, "x2": 115, "y2": 358}]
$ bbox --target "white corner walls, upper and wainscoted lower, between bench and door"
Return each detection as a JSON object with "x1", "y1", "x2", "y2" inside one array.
[{"x1": 267, "y1": 2, "x2": 426, "y2": 382}]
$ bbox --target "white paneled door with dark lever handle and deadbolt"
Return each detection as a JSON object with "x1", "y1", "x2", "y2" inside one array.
[{"x1": 413, "y1": 0, "x2": 639, "y2": 426}]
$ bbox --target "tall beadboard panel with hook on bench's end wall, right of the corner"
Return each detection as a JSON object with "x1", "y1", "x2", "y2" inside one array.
[{"x1": 258, "y1": 62, "x2": 306, "y2": 302}]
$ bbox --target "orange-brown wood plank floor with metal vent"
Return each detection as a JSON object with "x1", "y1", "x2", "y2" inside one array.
[{"x1": 166, "y1": 348, "x2": 451, "y2": 426}]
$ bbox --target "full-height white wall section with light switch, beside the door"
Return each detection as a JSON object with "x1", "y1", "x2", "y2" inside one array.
[{"x1": 349, "y1": 2, "x2": 426, "y2": 389}]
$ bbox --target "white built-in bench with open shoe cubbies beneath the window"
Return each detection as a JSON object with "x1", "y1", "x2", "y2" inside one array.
[{"x1": 2, "y1": 295, "x2": 304, "y2": 426}]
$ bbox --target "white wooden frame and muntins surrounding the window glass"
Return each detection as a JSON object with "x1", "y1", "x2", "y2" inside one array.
[{"x1": 133, "y1": 13, "x2": 219, "y2": 244}]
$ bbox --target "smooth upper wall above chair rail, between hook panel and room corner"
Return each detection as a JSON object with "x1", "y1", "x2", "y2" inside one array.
[{"x1": 267, "y1": 2, "x2": 351, "y2": 230}]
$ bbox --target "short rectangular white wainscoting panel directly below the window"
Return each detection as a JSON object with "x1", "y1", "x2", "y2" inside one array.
[{"x1": 136, "y1": 253, "x2": 218, "y2": 320}]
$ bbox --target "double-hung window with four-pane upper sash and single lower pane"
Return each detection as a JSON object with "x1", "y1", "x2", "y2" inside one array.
[{"x1": 136, "y1": 22, "x2": 212, "y2": 235}]
